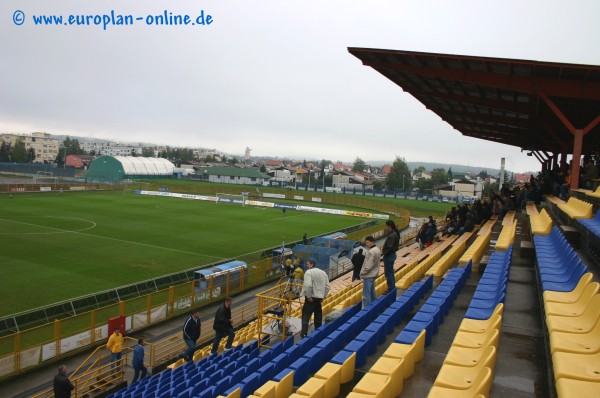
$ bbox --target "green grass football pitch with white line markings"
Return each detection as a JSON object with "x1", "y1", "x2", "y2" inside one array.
[{"x1": 0, "y1": 192, "x2": 368, "y2": 317}]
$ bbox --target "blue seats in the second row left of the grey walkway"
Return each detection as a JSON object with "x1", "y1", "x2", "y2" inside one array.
[{"x1": 394, "y1": 262, "x2": 472, "y2": 347}]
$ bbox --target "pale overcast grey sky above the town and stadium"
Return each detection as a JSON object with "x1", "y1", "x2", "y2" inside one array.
[{"x1": 0, "y1": 0, "x2": 600, "y2": 172}]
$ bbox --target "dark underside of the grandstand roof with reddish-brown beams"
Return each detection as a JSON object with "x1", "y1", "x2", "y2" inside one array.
[{"x1": 348, "y1": 48, "x2": 600, "y2": 154}]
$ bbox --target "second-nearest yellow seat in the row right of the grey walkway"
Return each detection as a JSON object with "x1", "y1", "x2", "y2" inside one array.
[{"x1": 552, "y1": 352, "x2": 600, "y2": 382}]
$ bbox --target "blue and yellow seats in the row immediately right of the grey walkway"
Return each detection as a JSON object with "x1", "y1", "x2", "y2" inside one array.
[{"x1": 534, "y1": 227, "x2": 600, "y2": 397}]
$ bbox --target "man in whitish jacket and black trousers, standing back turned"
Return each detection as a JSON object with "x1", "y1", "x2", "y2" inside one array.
[{"x1": 300, "y1": 258, "x2": 329, "y2": 337}]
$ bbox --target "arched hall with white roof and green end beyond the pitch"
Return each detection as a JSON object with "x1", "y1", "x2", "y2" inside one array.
[{"x1": 85, "y1": 155, "x2": 175, "y2": 182}]
